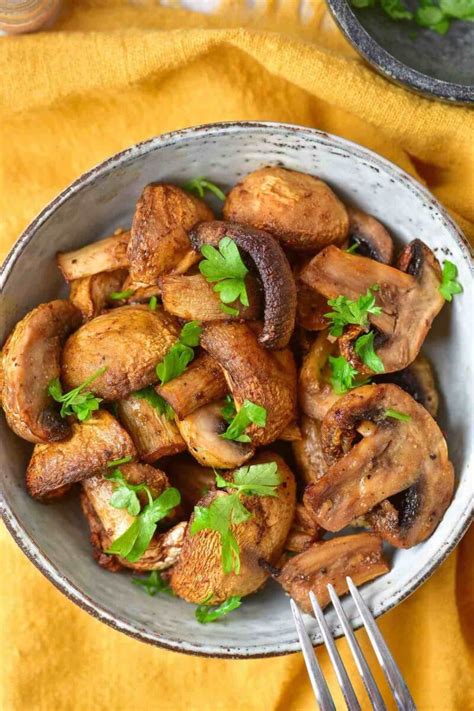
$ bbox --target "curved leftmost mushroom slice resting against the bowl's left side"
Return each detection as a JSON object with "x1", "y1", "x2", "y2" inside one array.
[{"x1": 0, "y1": 300, "x2": 82, "y2": 442}]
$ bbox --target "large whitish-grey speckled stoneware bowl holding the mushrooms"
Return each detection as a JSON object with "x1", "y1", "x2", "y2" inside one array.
[{"x1": 0, "y1": 123, "x2": 474, "y2": 657}]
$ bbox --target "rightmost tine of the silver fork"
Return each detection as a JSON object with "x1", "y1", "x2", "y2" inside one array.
[{"x1": 346, "y1": 577, "x2": 416, "y2": 711}]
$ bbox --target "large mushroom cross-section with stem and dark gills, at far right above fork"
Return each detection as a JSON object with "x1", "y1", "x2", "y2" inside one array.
[{"x1": 305, "y1": 383, "x2": 454, "y2": 548}]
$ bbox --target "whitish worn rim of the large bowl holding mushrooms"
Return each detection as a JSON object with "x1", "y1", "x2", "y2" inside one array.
[{"x1": 0, "y1": 121, "x2": 474, "y2": 659}]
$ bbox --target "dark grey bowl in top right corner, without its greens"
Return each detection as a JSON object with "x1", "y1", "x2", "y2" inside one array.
[{"x1": 327, "y1": 0, "x2": 474, "y2": 104}]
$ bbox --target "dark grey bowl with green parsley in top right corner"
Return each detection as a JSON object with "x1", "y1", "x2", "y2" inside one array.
[{"x1": 328, "y1": 0, "x2": 474, "y2": 104}]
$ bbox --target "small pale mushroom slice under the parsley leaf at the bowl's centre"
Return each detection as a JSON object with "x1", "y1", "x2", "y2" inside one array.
[{"x1": 176, "y1": 400, "x2": 255, "y2": 469}]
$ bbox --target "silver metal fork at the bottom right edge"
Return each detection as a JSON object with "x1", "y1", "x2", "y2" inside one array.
[{"x1": 290, "y1": 578, "x2": 416, "y2": 711}]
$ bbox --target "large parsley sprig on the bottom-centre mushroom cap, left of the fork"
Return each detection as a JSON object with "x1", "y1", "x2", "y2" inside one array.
[{"x1": 190, "y1": 462, "x2": 280, "y2": 575}]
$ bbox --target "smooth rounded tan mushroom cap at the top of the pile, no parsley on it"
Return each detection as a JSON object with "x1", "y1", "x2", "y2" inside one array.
[{"x1": 224, "y1": 167, "x2": 349, "y2": 252}]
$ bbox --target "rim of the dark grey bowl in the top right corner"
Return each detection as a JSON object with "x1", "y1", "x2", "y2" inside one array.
[{"x1": 326, "y1": 0, "x2": 474, "y2": 104}]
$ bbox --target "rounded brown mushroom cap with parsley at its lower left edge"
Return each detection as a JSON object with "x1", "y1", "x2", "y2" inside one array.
[{"x1": 61, "y1": 304, "x2": 179, "y2": 400}]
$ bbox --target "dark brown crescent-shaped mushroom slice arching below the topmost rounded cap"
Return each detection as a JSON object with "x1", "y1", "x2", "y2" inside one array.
[{"x1": 190, "y1": 221, "x2": 296, "y2": 349}]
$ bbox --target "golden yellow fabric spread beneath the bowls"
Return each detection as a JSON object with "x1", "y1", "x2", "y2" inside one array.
[{"x1": 0, "y1": 0, "x2": 474, "y2": 711}]
